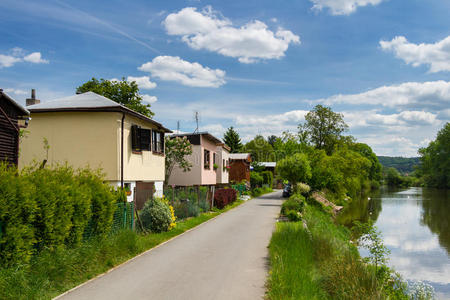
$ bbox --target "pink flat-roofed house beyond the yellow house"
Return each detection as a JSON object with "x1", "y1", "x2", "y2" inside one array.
[{"x1": 169, "y1": 132, "x2": 228, "y2": 186}]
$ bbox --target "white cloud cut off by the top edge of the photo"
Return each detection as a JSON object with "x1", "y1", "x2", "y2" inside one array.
[{"x1": 310, "y1": 0, "x2": 383, "y2": 15}]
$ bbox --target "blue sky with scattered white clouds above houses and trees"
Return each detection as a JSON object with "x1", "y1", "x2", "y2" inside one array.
[{"x1": 0, "y1": 0, "x2": 450, "y2": 156}]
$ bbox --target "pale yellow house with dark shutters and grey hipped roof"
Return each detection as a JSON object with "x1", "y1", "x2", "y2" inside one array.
[{"x1": 20, "y1": 92, "x2": 171, "y2": 206}]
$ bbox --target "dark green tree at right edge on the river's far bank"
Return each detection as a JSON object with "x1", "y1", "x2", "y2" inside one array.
[{"x1": 419, "y1": 122, "x2": 450, "y2": 189}]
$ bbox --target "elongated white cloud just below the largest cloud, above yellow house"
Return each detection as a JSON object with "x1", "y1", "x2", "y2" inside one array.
[{"x1": 138, "y1": 56, "x2": 226, "y2": 87}]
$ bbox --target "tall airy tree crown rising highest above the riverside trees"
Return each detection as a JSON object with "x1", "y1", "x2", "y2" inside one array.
[{"x1": 298, "y1": 104, "x2": 348, "y2": 154}]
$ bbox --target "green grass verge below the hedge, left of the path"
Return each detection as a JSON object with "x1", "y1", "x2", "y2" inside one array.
[{"x1": 0, "y1": 200, "x2": 243, "y2": 299}]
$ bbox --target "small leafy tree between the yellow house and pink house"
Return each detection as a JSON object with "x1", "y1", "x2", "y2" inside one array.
[{"x1": 164, "y1": 137, "x2": 192, "y2": 183}]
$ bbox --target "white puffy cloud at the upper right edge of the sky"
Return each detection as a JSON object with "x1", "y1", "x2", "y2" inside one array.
[{"x1": 380, "y1": 36, "x2": 450, "y2": 73}]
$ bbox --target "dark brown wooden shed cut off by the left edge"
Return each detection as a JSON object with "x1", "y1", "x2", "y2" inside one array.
[{"x1": 0, "y1": 89, "x2": 30, "y2": 166}]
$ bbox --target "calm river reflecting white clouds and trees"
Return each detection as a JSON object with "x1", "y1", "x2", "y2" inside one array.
[{"x1": 338, "y1": 187, "x2": 450, "y2": 299}]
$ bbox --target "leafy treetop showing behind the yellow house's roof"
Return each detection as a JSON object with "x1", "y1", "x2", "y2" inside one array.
[{"x1": 77, "y1": 78, "x2": 154, "y2": 118}]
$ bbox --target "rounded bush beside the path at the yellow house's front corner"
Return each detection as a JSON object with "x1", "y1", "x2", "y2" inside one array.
[{"x1": 140, "y1": 199, "x2": 172, "y2": 233}]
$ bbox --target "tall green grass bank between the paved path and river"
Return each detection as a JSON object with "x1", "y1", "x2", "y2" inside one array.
[{"x1": 267, "y1": 200, "x2": 407, "y2": 299}]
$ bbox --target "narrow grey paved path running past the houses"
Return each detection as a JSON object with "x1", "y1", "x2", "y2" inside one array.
[{"x1": 57, "y1": 191, "x2": 281, "y2": 300}]
